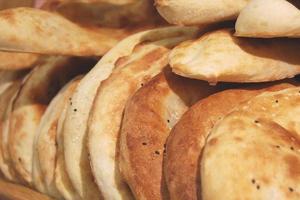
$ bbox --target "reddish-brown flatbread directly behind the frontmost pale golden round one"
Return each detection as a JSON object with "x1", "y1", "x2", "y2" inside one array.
[{"x1": 164, "y1": 83, "x2": 293, "y2": 200}]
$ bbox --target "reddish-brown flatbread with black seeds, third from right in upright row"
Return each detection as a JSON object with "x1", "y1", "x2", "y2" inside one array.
[{"x1": 119, "y1": 68, "x2": 217, "y2": 199}]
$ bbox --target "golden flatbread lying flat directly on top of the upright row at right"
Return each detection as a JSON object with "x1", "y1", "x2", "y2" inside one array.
[{"x1": 170, "y1": 29, "x2": 300, "y2": 83}]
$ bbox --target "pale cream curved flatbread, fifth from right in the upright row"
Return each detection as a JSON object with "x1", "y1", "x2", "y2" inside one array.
[{"x1": 63, "y1": 27, "x2": 199, "y2": 199}]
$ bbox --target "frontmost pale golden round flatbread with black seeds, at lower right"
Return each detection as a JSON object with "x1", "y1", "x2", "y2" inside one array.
[{"x1": 199, "y1": 87, "x2": 300, "y2": 200}]
